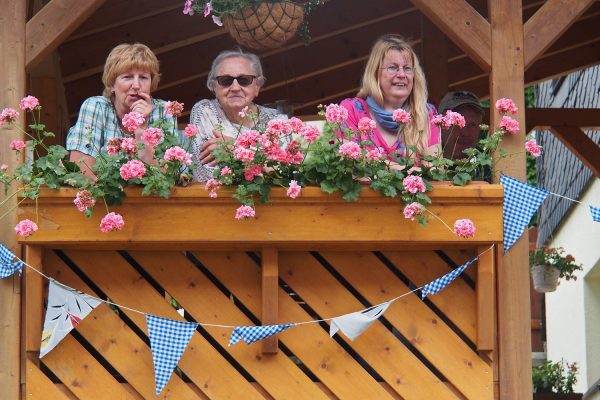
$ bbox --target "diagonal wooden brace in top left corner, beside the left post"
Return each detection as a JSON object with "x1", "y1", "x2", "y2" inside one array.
[{"x1": 25, "y1": 0, "x2": 105, "y2": 69}]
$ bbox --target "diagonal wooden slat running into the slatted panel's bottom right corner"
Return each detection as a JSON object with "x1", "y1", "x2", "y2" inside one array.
[{"x1": 321, "y1": 252, "x2": 493, "y2": 399}]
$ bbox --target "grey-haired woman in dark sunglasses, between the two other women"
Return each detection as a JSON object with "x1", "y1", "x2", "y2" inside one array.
[{"x1": 190, "y1": 49, "x2": 287, "y2": 182}]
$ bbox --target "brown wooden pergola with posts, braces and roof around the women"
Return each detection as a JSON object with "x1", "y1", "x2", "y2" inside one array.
[{"x1": 0, "y1": 0, "x2": 600, "y2": 399}]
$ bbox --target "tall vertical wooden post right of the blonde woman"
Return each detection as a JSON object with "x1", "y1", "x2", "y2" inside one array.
[{"x1": 488, "y1": 0, "x2": 532, "y2": 400}]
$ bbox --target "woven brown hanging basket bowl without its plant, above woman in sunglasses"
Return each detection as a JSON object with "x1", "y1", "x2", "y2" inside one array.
[{"x1": 223, "y1": 1, "x2": 304, "y2": 50}]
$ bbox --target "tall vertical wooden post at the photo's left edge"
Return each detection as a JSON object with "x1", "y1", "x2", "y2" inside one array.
[{"x1": 0, "y1": 0, "x2": 27, "y2": 399}]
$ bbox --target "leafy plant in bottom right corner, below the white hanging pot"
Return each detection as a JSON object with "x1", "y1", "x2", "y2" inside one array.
[{"x1": 531, "y1": 360, "x2": 583, "y2": 400}]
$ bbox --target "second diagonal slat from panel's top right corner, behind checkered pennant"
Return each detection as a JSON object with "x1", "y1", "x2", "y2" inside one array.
[{"x1": 384, "y1": 252, "x2": 477, "y2": 342}]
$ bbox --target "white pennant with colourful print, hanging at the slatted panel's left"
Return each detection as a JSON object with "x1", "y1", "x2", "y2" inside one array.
[{"x1": 40, "y1": 280, "x2": 101, "y2": 358}]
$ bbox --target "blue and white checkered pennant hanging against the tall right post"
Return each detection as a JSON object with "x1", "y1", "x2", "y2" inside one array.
[{"x1": 500, "y1": 175, "x2": 549, "y2": 253}]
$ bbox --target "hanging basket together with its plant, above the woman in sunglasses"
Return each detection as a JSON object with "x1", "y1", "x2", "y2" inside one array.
[{"x1": 183, "y1": 0, "x2": 325, "y2": 50}]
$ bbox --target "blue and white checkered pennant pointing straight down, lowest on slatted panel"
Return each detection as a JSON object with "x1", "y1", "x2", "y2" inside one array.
[{"x1": 146, "y1": 314, "x2": 198, "y2": 396}]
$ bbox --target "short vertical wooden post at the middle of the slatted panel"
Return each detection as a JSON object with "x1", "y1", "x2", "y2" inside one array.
[{"x1": 261, "y1": 247, "x2": 279, "y2": 354}]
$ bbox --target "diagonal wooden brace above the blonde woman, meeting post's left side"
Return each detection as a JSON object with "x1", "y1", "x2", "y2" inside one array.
[{"x1": 411, "y1": 0, "x2": 492, "y2": 71}]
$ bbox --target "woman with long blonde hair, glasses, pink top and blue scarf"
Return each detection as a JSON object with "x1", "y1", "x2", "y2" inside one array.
[{"x1": 341, "y1": 34, "x2": 441, "y2": 159}]
